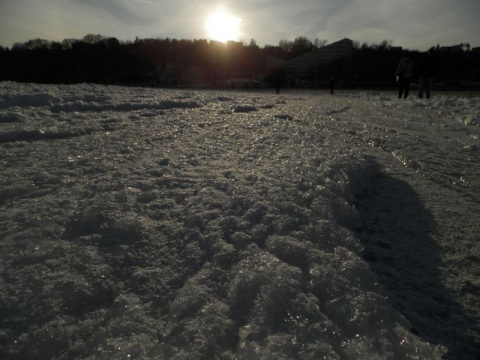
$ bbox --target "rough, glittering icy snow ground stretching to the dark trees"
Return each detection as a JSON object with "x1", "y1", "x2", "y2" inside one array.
[{"x1": 0, "y1": 82, "x2": 480, "y2": 360}]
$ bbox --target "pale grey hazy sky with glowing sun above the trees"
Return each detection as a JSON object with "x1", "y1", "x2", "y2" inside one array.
[{"x1": 0, "y1": 0, "x2": 480, "y2": 51}]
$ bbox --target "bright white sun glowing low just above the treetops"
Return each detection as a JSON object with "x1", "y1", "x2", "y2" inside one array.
[{"x1": 205, "y1": 9, "x2": 242, "y2": 42}]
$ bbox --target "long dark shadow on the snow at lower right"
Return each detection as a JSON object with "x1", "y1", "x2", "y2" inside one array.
[{"x1": 355, "y1": 175, "x2": 480, "y2": 360}]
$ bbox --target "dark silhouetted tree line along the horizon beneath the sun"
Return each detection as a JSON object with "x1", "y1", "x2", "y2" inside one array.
[{"x1": 0, "y1": 34, "x2": 480, "y2": 87}]
